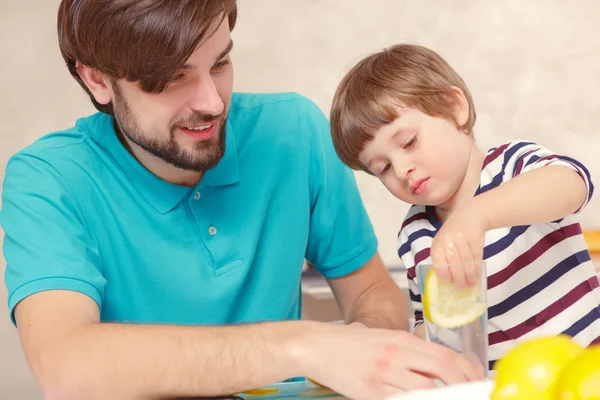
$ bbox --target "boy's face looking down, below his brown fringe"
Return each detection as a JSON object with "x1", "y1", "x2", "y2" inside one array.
[{"x1": 359, "y1": 108, "x2": 474, "y2": 206}]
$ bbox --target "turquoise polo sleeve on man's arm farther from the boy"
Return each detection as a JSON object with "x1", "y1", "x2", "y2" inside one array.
[{"x1": 0, "y1": 153, "x2": 106, "y2": 323}]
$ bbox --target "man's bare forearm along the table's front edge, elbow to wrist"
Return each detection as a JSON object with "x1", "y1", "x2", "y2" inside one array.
[{"x1": 37, "y1": 322, "x2": 308, "y2": 400}]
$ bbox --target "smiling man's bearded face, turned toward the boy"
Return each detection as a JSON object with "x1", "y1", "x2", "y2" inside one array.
[{"x1": 112, "y1": 18, "x2": 233, "y2": 172}]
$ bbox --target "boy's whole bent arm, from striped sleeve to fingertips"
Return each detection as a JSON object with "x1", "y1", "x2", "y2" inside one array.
[{"x1": 431, "y1": 142, "x2": 594, "y2": 287}]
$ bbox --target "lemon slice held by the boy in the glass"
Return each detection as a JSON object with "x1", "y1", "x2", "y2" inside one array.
[{"x1": 423, "y1": 269, "x2": 487, "y2": 329}]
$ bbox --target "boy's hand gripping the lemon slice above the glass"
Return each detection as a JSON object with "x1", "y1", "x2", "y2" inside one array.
[{"x1": 431, "y1": 203, "x2": 487, "y2": 288}]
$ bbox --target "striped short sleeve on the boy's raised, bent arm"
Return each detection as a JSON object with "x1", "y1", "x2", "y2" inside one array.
[{"x1": 503, "y1": 141, "x2": 594, "y2": 213}]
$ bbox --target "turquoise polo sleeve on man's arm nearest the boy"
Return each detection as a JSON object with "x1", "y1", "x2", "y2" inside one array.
[{"x1": 302, "y1": 100, "x2": 377, "y2": 278}]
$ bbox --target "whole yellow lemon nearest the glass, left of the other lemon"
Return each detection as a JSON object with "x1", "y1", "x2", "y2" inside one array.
[{"x1": 492, "y1": 335, "x2": 583, "y2": 400}]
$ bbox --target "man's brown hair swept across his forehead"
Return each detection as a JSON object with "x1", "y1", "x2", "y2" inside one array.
[{"x1": 58, "y1": 0, "x2": 237, "y2": 114}]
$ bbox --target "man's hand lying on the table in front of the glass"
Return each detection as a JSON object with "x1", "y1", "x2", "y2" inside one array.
[{"x1": 298, "y1": 324, "x2": 483, "y2": 399}]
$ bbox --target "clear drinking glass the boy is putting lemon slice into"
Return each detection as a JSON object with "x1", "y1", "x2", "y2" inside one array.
[{"x1": 416, "y1": 262, "x2": 490, "y2": 378}]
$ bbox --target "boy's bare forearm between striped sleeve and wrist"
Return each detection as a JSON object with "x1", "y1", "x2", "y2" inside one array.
[{"x1": 470, "y1": 165, "x2": 587, "y2": 230}]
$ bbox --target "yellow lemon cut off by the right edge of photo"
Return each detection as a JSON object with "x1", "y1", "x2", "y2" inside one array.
[{"x1": 556, "y1": 345, "x2": 600, "y2": 400}]
